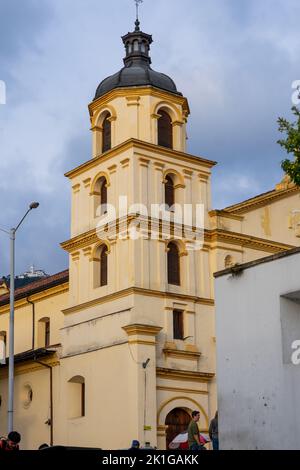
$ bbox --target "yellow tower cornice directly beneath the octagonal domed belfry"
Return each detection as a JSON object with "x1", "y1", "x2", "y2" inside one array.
[{"x1": 65, "y1": 139, "x2": 216, "y2": 179}]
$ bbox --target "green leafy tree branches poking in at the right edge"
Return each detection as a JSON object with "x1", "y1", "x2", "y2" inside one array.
[{"x1": 278, "y1": 100, "x2": 300, "y2": 186}]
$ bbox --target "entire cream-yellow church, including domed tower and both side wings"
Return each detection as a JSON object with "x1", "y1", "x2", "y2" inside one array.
[{"x1": 0, "y1": 21, "x2": 300, "y2": 449}]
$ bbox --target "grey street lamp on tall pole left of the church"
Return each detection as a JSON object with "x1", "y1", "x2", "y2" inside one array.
[{"x1": 0, "y1": 202, "x2": 39, "y2": 433}]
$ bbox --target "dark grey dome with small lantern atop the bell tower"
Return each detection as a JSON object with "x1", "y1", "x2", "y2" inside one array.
[{"x1": 94, "y1": 21, "x2": 181, "y2": 100}]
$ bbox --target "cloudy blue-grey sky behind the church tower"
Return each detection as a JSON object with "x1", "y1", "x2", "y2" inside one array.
[{"x1": 0, "y1": 0, "x2": 300, "y2": 274}]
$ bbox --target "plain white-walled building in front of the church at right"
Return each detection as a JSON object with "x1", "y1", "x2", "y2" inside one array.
[{"x1": 215, "y1": 248, "x2": 300, "y2": 450}]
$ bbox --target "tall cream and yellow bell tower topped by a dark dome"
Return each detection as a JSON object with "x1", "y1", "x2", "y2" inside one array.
[{"x1": 62, "y1": 19, "x2": 214, "y2": 448}]
